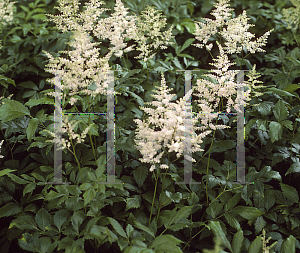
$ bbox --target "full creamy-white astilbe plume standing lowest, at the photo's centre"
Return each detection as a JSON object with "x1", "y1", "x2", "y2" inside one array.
[{"x1": 134, "y1": 75, "x2": 227, "y2": 171}]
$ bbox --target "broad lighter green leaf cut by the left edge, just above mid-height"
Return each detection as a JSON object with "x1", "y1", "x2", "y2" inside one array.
[{"x1": 0, "y1": 100, "x2": 30, "y2": 122}]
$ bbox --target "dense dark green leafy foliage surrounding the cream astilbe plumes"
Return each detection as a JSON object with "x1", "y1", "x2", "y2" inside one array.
[{"x1": 0, "y1": 0, "x2": 300, "y2": 253}]
